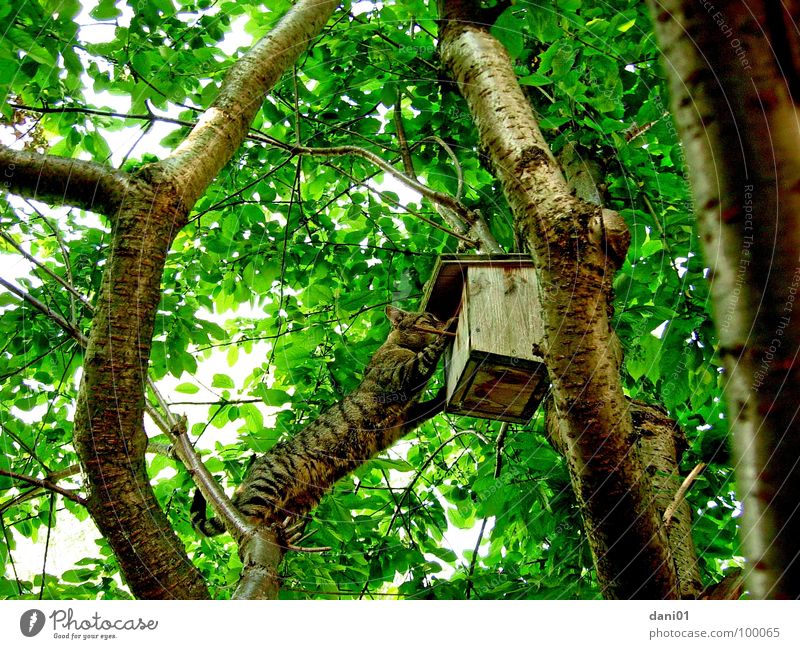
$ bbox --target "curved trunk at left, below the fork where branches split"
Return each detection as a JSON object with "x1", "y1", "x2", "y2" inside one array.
[{"x1": 75, "y1": 171, "x2": 208, "y2": 599}]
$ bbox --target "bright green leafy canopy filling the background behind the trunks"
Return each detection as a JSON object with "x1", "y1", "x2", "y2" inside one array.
[{"x1": 0, "y1": 0, "x2": 737, "y2": 598}]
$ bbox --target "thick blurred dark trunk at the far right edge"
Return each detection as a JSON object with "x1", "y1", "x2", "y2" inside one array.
[{"x1": 651, "y1": 0, "x2": 800, "y2": 599}]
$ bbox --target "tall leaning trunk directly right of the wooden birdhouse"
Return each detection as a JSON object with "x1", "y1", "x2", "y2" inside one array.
[{"x1": 440, "y1": 0, "x2": 679, "y2": 599}]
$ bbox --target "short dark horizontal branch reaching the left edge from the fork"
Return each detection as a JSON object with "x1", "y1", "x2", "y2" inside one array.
[{"x1": 0, "y1": 144, "x2": 128, "y2": 218}]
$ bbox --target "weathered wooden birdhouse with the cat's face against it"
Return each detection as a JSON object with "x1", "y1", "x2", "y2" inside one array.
[{"x1": 422, "y1": 255, "x2": 549, "y2": 423}]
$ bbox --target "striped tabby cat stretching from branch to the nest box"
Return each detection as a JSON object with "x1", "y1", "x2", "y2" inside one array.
[{"x1": 191, "y1": 306, "x2": 450, "y2": 536}]
